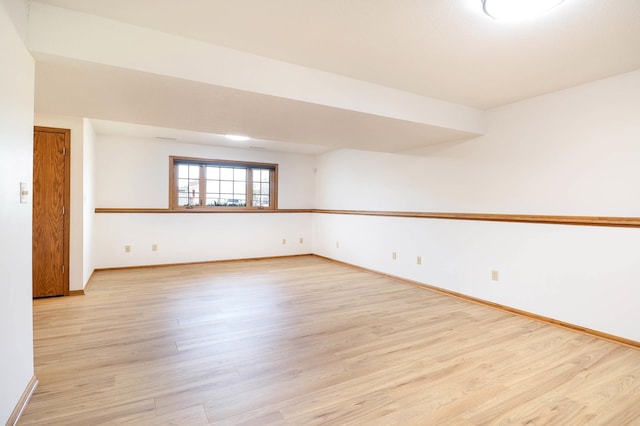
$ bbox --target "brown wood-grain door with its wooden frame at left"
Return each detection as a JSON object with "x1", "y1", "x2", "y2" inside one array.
[{"x1": 33, "y1": 127, "x2": 71, "y2": 297}]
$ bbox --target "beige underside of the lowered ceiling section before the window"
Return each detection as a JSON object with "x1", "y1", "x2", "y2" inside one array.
[{"x1": 36, "y1": 55, "x2": 474, "y2": 154}]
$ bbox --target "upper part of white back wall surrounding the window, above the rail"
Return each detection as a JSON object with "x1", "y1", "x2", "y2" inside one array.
[{"x1": 95, "y1": 135, "x2": 315, "y2": 209}]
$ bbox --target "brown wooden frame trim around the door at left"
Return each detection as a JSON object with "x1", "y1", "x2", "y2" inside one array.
[{"x1": 31, "y1": 126, "x2": 71, "y2": 296}]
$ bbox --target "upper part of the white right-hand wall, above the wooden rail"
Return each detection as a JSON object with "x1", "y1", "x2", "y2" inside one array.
[{"x1": 316, "y1": 71, "x2": 640, "y2": 216}]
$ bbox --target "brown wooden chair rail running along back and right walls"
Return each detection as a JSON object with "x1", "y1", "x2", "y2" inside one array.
[{"x1": 95, "y1": 208, "x2": 640, "y2": 228}]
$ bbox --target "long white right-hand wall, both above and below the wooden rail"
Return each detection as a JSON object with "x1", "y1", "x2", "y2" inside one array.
[{"x1": 314, "y1": 71, "x2": 640, "y2": 341}]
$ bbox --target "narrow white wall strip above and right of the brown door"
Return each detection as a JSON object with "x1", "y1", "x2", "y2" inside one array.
[{"x1": 35, "y1": 112, "x2": 91, "y2": 290}]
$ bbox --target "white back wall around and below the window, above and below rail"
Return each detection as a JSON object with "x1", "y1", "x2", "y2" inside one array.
[{"x1": 93, "y1": 135, "x2": 315, "y2": 268}]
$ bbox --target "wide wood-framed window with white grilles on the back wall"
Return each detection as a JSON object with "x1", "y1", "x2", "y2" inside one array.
[{"x1": 169, "y1": 157, "x2": 278, "y2": 211}]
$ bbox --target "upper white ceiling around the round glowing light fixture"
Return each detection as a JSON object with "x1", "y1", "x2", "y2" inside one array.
[{"x1": 31, "y1": 0, "x2": 640, "y2": 151}]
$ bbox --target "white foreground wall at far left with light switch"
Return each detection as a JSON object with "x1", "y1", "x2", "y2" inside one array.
[{"x1": 0, "y1": 0, "x2": 34, "y2": 423}]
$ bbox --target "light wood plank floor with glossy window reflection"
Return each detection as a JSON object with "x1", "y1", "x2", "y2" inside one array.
[{"x1": 20, "y1": 256, "x2": 640, "y2": 426}]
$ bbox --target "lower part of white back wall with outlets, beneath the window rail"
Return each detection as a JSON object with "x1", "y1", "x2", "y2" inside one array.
[{"x1": 93, "y1": 213, "x2": 312, "y2": 268}]
